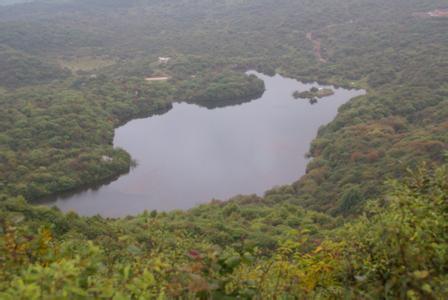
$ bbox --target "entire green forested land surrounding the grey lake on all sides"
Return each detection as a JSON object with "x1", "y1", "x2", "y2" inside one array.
[{"x1": 0, "y1": 0, "x2": 448, "y2": 299}]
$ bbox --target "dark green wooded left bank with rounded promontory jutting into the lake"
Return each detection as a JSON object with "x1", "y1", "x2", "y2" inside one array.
[{"x1": 0, "y1": 64, "x2": 264, "y2": 200}]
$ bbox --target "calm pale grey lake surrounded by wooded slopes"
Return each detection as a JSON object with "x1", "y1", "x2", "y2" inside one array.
[{"x1": 41, "y1": 72, "x2": 364, "y2": 217}]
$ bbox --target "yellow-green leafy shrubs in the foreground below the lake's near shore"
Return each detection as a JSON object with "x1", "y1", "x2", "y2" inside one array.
[{"x1": 0, "y1": 166, "x2": 448, "y2": 299}]
